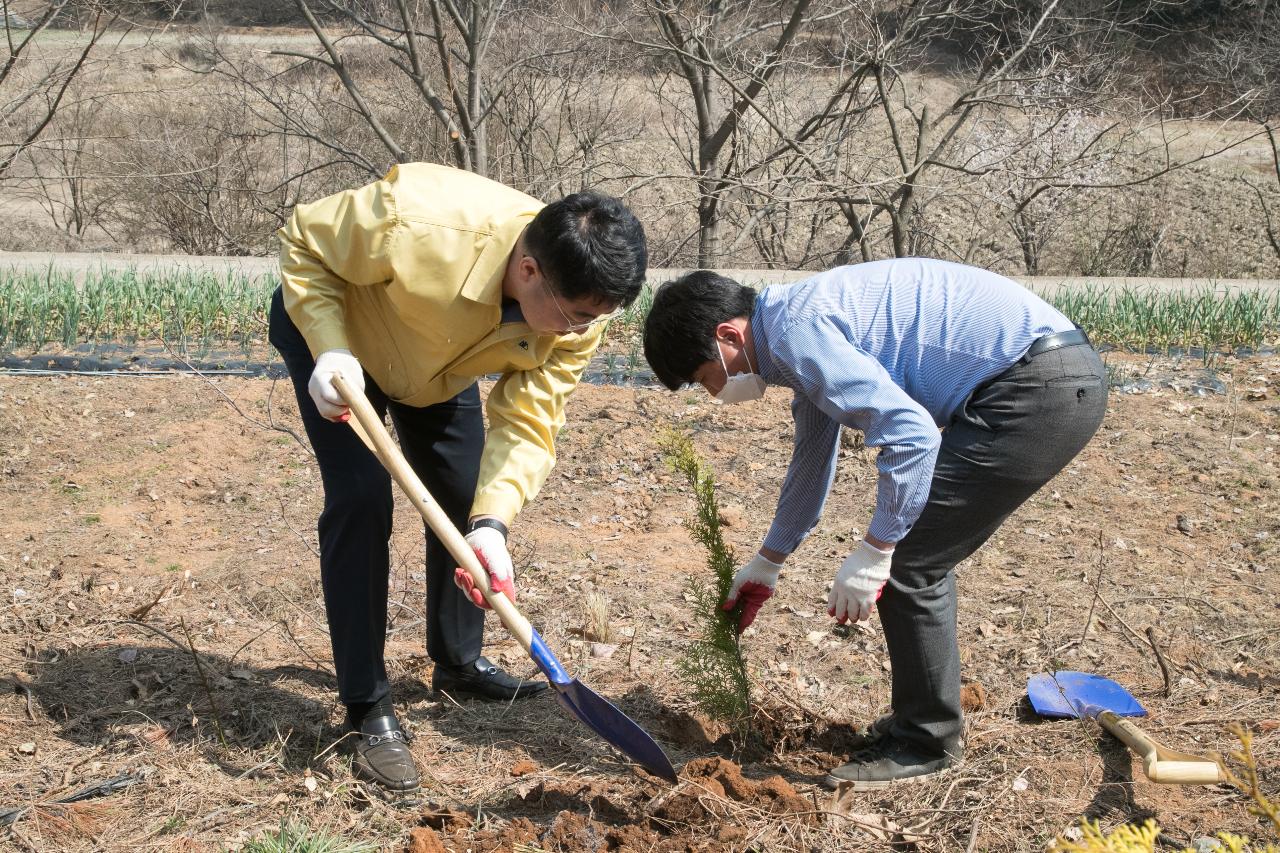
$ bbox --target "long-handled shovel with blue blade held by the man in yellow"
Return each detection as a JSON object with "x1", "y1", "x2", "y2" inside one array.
[{"x1": 333, "y1": 377, "x2": 676, "y2": 783}]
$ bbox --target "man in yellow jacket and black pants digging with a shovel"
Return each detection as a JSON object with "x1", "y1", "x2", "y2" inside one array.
[{"x1": 270, "y1": 163, "x2": 646, "y2": 790}]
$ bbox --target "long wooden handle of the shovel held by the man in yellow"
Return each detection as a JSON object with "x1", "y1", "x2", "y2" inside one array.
[{"x1": 333, "y1": 374, "x2": 534, "y2": 645}]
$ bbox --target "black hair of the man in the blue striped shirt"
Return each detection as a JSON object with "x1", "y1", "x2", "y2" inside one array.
[{"x1": 644, "y1": 269, "x2": 758, "y2": 391}]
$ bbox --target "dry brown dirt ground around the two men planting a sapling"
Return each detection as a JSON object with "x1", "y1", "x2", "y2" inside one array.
[{"x1": 0, "y1": 359, "x2": 1280, "y2": 852}]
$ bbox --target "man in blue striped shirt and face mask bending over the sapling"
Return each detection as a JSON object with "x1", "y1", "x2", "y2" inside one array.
[{"x1": 644, "y1": 259, "x2": 1107, "y2": 790}]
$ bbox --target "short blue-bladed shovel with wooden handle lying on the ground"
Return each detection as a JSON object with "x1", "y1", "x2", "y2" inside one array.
[{"x1": 1027, "y1": 670, "x2": 1226, "y2": 785}]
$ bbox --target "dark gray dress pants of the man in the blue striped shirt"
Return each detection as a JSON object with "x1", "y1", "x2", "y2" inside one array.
[{"x1": 877, "y1": 345, "x2": 1107, "y2": 757}]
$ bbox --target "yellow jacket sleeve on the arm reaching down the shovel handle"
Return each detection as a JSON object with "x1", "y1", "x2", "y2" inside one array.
[{"x1": 471, "y1": 325, "x2": 604, "y2": 525}]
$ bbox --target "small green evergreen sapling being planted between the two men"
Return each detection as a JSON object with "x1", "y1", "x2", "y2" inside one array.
[{"x1": 660, "y1": 430, "x2": 751, "y2": 738}]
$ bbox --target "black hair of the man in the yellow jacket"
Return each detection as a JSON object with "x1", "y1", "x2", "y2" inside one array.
[{"x1": 525, "y1": 191, "x2": 649, "y2": 306}]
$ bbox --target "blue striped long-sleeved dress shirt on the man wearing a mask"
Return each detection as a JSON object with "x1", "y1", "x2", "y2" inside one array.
[{"x1": 751, "y1": 257, "x2": 1075, "y2": 553}]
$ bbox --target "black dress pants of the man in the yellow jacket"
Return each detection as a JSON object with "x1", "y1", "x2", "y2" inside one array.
[{"x1": 270, "y1": 288, "x2": 484, "y2": 704}]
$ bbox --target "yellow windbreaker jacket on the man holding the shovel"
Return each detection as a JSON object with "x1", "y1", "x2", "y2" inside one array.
[{"x1": 279, "y1": 163, "x2": 602, "y2": 524}]
